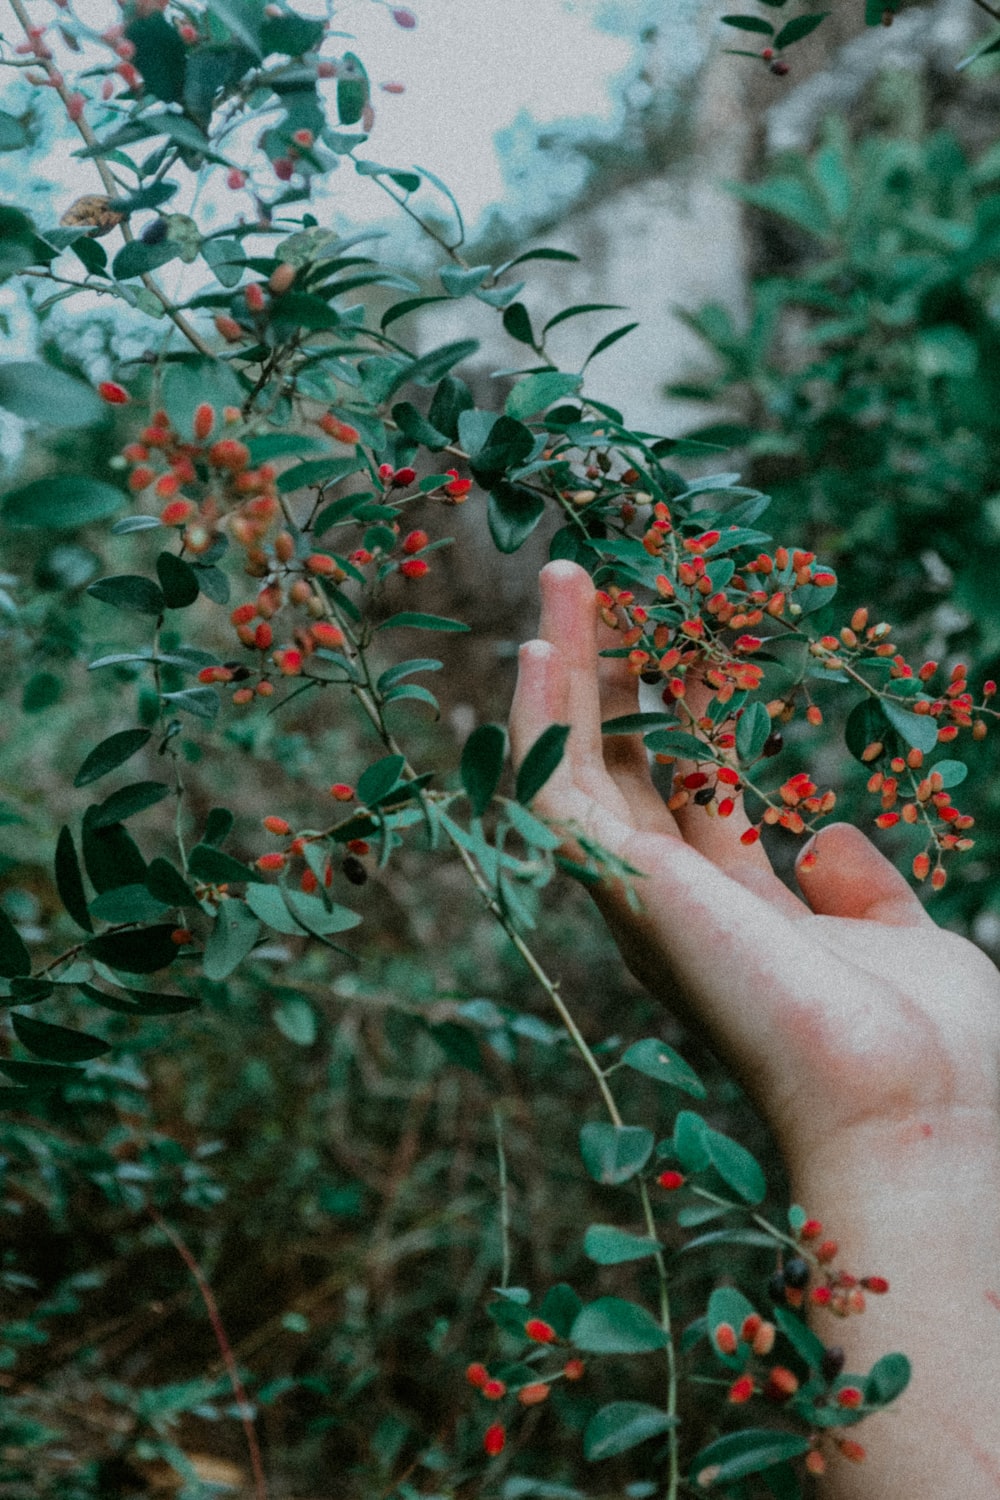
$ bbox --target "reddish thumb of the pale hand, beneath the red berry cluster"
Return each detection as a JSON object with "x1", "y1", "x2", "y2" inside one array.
[{"x1": 795, "y1": 824, "x2": 931, "y2": 927}]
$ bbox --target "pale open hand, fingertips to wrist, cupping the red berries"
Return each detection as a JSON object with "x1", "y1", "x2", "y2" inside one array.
[{"x1": 511, "y1": 563, "x2": 1000, "y2": 1160}]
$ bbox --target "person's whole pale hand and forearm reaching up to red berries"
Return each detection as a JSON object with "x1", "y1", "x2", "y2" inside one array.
[{"x1": 511, "y1": 561, "x2": 1000, "y2": 1500}]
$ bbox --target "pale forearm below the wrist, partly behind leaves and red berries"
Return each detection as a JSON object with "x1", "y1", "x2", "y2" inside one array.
[{"x1": 790, "y1": 1112, "x2": 1000, "y2": 1500}]
